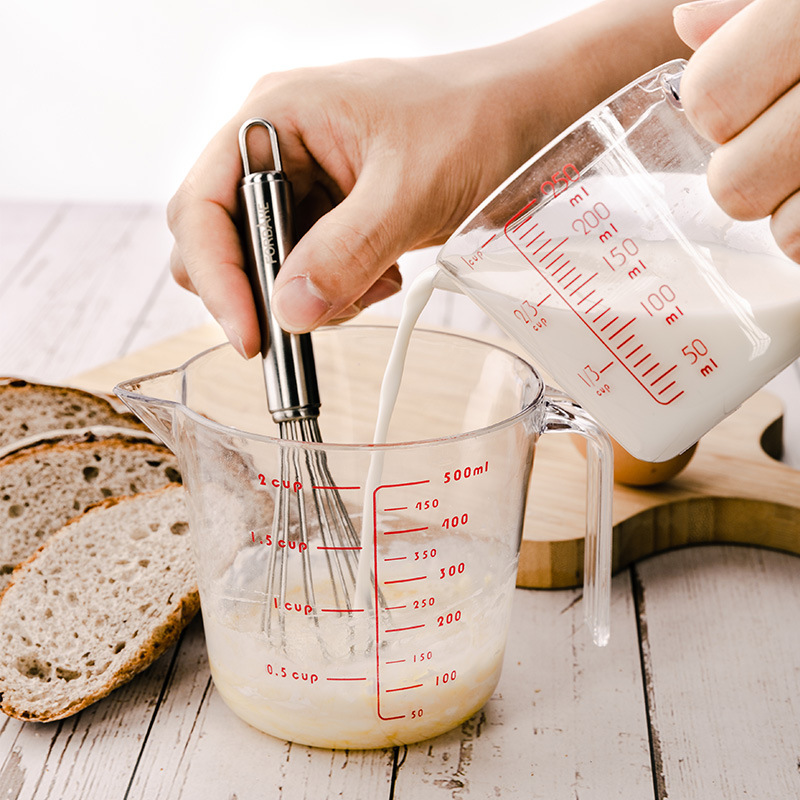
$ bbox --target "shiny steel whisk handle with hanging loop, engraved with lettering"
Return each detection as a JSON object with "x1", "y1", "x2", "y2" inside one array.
[{"x1": 239, "y1": 119, "x2": 320, "y2": 423}]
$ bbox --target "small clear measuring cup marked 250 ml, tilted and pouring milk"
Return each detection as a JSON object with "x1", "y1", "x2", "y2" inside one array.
[{"x1": 437, "y1": 61, "x2": 800, "y2": 461}]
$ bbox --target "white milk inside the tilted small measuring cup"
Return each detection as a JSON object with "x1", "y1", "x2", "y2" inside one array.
[{"x1": 440, "y1": 242, "x2": 800, "y2": 461}]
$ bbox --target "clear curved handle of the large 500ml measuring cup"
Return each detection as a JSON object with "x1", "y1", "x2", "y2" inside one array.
[{"x1": 542, "y1": 387, "x2": 614, "y2": 646}]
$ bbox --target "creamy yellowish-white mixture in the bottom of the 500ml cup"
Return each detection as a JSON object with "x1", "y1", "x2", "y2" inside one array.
[{"x1": 203, "y1": 537, "x2": 516, "y2": 748}]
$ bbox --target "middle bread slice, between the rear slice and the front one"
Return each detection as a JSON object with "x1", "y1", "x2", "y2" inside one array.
[{"x1": 0, "y1": 430, "x2": 181, "y2": 589}]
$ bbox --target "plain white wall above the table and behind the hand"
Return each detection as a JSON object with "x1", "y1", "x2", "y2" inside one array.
[{"x1": 0, "y1": 0, "x2": 590, "y2": 203}]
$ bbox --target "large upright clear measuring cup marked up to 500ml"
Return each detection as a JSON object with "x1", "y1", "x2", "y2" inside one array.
[{"x1": 116, "y1": 326, "x2": 611, "y2": 748}]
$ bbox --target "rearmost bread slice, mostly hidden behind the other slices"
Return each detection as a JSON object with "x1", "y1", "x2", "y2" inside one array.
[{"x1": 0, "y1": 378, "x2": 144, "y2": 446}]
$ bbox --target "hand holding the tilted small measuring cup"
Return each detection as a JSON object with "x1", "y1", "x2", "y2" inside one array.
[{"x1": 674, "y1": 0, "x2": 800, "y2": 262}]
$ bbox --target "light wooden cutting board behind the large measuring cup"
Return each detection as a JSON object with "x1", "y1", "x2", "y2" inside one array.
[{"x1": 72, "y1": 326, "x2": 800, "y2": 589}]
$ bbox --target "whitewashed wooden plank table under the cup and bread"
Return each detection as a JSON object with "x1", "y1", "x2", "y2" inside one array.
[{"x1": 0, "y1": 202, "x2": 800, "y2": 800}]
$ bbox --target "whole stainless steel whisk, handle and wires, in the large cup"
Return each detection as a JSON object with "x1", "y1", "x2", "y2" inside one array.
[{"x1": 239, "y1": 119, "x2": 360, "y2": 635}]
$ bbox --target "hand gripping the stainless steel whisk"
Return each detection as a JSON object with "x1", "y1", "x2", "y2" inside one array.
[{"x1": 168, "y1": 54, "x2": 525, "y2": 356}]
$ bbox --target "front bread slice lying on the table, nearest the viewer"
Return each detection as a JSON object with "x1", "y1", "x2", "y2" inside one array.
[{"x1": 0, "y1": 486, "x2": 200, "y2": 722}]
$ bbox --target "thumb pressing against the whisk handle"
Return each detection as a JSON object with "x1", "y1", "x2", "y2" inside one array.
[{"x1": 272, "y1": 167, "x2": 417, "y2": 333}]
